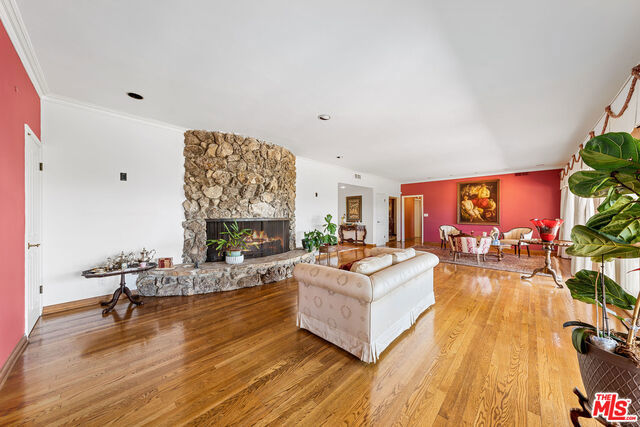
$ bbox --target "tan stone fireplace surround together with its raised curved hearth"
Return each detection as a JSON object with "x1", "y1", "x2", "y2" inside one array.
[{"x1": 137, "y1": 130, "x2": 308, "y2": 296}]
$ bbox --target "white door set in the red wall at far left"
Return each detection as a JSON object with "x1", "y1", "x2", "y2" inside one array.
[{"x1": 25, "y1": 126, "x2": 43, "y2": 335}]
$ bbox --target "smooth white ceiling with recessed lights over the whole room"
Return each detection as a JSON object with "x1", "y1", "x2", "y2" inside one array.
[{"x1": 12, "y1": 0, "x2": 640, "y2": 182}]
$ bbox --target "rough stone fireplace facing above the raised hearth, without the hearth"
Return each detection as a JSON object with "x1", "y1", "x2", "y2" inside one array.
[{"x1": 182, "y1": 130, "x2": 296, "y2": 263}]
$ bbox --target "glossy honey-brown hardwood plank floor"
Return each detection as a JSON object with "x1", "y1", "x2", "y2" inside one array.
[{"x1": 0, "y1": 251, "x2": 594, "y2": 426}]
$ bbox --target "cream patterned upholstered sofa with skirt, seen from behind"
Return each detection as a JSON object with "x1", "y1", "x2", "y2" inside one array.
[{"x1": 293, "y1": 248, "x2": 439, "y2": 363}]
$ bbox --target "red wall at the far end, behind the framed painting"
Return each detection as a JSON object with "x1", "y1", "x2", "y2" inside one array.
[{"x1": 401, "y1": 169, "x2": 560, "y2": 242}]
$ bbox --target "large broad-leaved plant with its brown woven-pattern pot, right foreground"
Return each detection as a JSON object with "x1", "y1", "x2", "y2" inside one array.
[{"x1": 565, "y1": 133, "x2": 640, "y2": 415}]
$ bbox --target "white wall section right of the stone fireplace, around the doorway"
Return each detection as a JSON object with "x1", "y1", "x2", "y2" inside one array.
[{"x1": 296, "y1": 157, "x2": 400, "y2": 246}]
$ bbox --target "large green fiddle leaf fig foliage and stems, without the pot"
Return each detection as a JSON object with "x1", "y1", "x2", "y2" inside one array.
[{"x1": 564, "y1": 132, "x2": 640, "y2": 362}]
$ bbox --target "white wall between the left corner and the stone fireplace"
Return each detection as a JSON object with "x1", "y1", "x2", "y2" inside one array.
[{"x1": 42, "y1": 98, "x2": 184, "y2": 306}]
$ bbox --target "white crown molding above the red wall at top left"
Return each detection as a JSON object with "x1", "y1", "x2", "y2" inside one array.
[{"x1": 0, "y1": 0, "x2": 49, "y2": 98}]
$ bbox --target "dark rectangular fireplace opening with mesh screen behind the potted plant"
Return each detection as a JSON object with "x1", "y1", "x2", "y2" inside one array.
[{"x1": 207, "y1": 218, "x2": 289, "y2": 262}]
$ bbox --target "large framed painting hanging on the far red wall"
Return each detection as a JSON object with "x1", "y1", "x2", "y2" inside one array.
[{"x1": 456, "y1": 179, "x2": 500, "y2": 225}]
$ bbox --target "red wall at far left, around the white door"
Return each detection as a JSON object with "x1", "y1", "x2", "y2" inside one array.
[{"x1": 0, "y1": 19, "x2": 40, "y2": 366}]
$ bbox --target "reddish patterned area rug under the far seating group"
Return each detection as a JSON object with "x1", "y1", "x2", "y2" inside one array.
[{"x1": 413, "y1": 245, "x2": 561, "y2": 273}]
